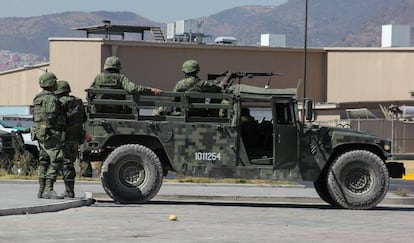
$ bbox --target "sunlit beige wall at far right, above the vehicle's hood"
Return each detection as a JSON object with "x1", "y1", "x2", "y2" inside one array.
[{"x1": 326, "y1": 48, "x2": 414, "y2": 102}]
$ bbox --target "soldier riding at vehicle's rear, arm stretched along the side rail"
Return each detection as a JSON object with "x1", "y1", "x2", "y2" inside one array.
[{"x1": 88, "y1": 56, "x2": 162, "y2": 113}]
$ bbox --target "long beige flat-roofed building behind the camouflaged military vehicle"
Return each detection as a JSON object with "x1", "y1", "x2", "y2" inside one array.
[{"x1": 0, "y1": 38, "x2": 414, "y2": 152}]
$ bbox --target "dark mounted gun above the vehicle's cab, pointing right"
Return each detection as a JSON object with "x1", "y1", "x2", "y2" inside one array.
[{"x1": 207, "y1": 70, "x2": 282, "y2": 92}]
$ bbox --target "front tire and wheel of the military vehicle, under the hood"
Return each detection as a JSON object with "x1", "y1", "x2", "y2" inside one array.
[{"x1": 327, "y1": 150, "x2": 390, "y2": 209}]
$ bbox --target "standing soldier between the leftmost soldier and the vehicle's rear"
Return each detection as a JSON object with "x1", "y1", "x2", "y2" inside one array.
[{"x1": 55, "y1": 80, "x2": 86, "y2": 198}]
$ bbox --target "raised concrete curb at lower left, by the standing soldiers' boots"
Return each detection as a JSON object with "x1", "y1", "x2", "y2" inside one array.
[{"x1": 0, "y1": 196, "x2": 95, "y2": 216}]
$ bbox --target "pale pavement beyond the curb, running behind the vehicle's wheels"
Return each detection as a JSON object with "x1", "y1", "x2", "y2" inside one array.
[{"x1": 0, "y1": 180, "x2": 414, "y2": 216}]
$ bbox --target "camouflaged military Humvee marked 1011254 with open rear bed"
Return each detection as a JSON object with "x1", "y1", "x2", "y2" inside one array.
[{"x1": 82, "y1": 73, "x2": 404, "y2": 209}]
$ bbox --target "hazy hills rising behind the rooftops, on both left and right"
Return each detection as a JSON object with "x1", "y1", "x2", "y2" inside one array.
[{"x1": 0, "y1": 0, "x2": 414, "y2": 70}]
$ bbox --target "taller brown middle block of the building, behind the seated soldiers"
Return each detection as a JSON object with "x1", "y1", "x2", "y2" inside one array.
[{"x1": 50, "y1": 38, "x2": 326, "y2": 101}]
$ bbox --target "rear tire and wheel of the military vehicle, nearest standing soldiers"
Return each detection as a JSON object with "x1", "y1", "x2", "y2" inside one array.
[{"x1": 101, "y1": 144, "x2": 163, "y2": 204}]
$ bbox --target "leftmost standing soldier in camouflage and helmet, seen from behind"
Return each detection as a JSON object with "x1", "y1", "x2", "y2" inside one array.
[{"x1": 31, "y1": 72, "x2": 65, "y2": 199}]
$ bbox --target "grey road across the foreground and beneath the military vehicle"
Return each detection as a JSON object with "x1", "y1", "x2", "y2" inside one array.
[{"x1": 0, "y1": 181, "x2": 414, "y2": 243}]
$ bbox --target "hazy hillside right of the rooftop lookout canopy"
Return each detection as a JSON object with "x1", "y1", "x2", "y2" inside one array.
[{"x1": 204, "y1": 0, "x2": 414, "y2": 47}]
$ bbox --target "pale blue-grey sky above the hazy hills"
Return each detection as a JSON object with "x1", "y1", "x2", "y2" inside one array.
[{"x1": 0, "y1": 0, "x2": 287, "y2": 23}]
